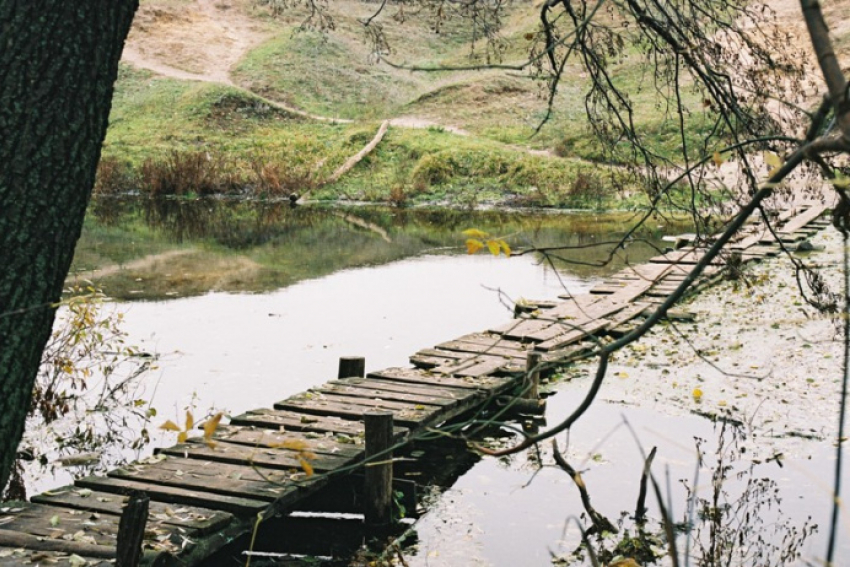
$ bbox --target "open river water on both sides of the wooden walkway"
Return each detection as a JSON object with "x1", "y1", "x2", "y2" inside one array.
[{"x1": 34, "y1": 202, "x2": 832, "y2": 566}]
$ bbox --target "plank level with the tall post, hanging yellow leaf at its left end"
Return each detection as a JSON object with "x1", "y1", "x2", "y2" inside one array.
[{"x1": 209, "y1": 425, "x2": 363, "y2": 458}]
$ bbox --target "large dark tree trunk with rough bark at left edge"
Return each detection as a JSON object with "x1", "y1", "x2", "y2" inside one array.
[{"x1": 0, "y1": 0, "x2": 138, "y2": 489}]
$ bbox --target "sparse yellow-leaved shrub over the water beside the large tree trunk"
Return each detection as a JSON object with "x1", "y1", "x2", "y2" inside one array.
[{"x1": 13, "y1": 286, "x2": 156, "y2": 490}]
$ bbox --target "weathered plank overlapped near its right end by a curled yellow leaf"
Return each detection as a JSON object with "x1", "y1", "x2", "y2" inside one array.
[{"x1": 158, "y1": 441, "x2": 357, "y2": 473}]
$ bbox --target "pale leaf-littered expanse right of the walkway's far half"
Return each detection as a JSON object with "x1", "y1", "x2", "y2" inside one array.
[{"x1": 562, "y1": 227, "x2": 842, "y2": 459}]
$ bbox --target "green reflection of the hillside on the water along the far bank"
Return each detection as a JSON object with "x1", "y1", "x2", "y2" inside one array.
[{"x1": 72, "y1": 198, "x2": 686, "y2": 299}]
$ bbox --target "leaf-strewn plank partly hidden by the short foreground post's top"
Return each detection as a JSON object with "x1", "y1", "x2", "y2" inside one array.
[{"x1": 32, "y1": 486, "x2": 233, "y2": 535}]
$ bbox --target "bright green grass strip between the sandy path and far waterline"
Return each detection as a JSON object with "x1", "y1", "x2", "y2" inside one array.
[{"x1": 104, "y1": 62, "x2": 644, "y2": 207}]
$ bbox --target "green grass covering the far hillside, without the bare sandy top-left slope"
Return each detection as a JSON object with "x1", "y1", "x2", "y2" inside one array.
[{"x1": 104, "y1": 0, "x2": 728, "y2": 208}]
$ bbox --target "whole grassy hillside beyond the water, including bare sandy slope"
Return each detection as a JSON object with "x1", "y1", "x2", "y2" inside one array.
[{"x1": 109, "y1": 0, "x2": 847, "y2": 207}]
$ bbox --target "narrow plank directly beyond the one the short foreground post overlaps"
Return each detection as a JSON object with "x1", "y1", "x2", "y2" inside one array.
[{"x1": 74, "y1": 476, "x2": 268, "y2": 516}]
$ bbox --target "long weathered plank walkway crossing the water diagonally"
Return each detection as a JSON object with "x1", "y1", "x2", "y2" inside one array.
[{"x1": 0, "y1": 205, "x2": 826, "y2": 566}]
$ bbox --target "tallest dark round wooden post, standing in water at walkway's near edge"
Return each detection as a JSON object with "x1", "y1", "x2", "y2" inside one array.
[{"x1": 363, "y1": 410, "x2": 393, "y2": 526}]
